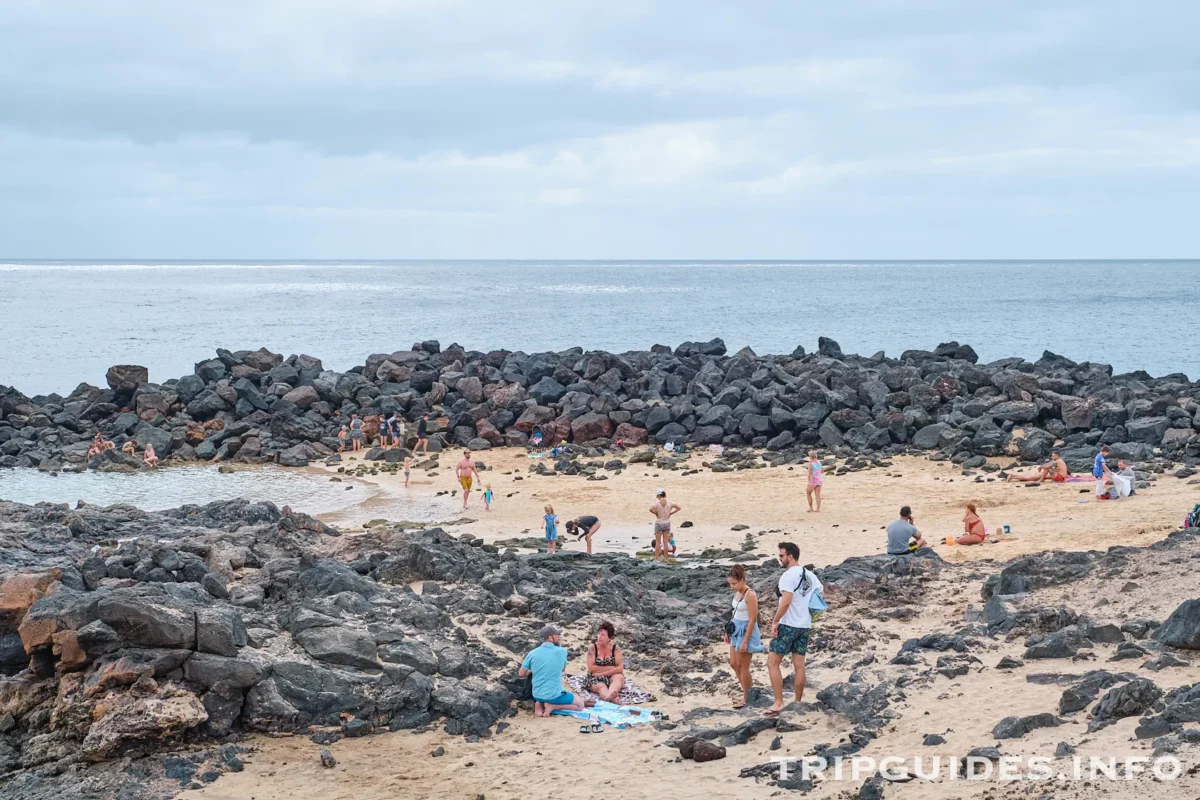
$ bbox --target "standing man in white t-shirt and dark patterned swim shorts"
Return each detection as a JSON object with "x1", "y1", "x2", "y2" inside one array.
[{"x1": 763, "y1": 542, "x2": 821, "y2": 716}]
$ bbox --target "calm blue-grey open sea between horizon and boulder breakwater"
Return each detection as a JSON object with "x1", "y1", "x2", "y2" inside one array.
[{"x1": 0, "y1": 260, "x2": 1200, "y2": 395}]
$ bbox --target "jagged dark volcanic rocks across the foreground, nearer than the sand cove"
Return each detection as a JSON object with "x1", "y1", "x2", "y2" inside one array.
[{"x1": 0, "y1": 500, "x2": 1200, "y2": 800}]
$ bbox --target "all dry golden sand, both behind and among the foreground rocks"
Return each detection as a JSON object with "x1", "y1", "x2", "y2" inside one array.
[{"x1": 192, "y1": 451, "x2": 1200, "y2": 800}]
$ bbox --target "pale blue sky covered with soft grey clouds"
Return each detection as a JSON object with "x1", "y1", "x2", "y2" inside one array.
[{"x1": 0, "y1": 0, "x2": 1200, "y2": 259}]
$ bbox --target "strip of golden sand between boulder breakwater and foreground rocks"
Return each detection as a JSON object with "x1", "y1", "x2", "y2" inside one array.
[{"x1": 319, "y1": 449, "x2": 1200, "y2": 566}]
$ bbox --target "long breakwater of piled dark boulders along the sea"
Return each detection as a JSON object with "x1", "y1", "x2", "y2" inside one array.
[{"x1": 7, "y1": 338, "x2": 1200, "y2": 471}]
